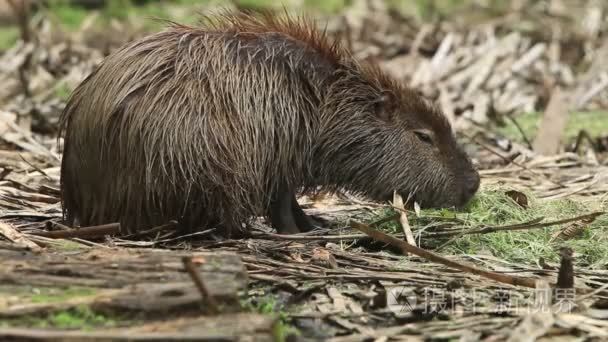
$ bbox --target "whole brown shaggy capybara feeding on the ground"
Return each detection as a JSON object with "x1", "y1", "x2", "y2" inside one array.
[{"x1": 61, "y1": 13, "x2": 479, "y2": 236}]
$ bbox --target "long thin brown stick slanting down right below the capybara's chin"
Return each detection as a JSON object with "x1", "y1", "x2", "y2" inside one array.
[{"x1": 350, "y1": 221, "x2": 536, "y2": 288}]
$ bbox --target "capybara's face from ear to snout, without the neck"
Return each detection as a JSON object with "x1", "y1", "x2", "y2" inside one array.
[{"x1": 373, "y1": 87, "x2": 479, "y2": 207}]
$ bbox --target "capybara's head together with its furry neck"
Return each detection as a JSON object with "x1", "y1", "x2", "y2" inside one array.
[{"x1": 324, "y1": 65, "x2": 479, "y2": 207}]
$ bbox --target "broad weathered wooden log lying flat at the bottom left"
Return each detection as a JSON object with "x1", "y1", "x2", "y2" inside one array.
[{"x1": 0, "y1": 248, "x2": 248, "y2": 317}]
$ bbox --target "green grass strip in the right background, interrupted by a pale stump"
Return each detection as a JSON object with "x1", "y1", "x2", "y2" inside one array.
[{"x1": 497, "y1": 111, "x2": 608, "y2": 146}]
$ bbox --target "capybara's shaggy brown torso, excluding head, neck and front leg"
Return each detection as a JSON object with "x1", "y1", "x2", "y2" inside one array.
[{"x1": 62, "y1": 17, "x2": 331, "y2": 234}]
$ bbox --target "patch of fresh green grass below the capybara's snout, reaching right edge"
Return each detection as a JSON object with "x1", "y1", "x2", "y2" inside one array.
[{"x1": 374, "y1": 188, "x2": 608, "y2": 269}]
